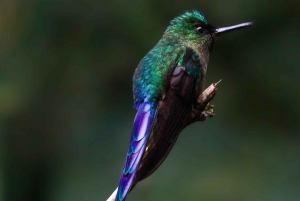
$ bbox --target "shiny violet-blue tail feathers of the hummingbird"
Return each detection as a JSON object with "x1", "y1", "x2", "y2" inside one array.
[{"x1": 115, "y1": 102, "x2": 157, "y2": 201}]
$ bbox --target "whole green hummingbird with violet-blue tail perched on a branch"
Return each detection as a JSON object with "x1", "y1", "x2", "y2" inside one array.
[{"x1": 115, "y1": 11, "x2": 252, "y2": 201}]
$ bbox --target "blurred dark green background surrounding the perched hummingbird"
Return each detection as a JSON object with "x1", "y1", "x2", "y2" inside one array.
[{"x1": 0, "y1": 0, "x2": 300, "y2": 201}]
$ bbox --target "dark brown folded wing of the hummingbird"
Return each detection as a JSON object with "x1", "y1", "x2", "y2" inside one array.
[{"x1": 134, "y1": 47, "x2": 201, "y2": 184}]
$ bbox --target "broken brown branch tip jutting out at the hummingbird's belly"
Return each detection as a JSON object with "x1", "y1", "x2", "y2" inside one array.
[{"x1": 185, "y1": 80, "x2": 221, "y2": 127}]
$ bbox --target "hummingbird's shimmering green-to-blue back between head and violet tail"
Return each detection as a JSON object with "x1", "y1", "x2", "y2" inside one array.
[{"x1": 133, "y1": 38, "x2": 185, "y2": 106}]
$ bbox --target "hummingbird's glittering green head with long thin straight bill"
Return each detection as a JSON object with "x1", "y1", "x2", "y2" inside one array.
[{"x1": 164, "y1": 11, "x2": 252, "y2": 50}]
